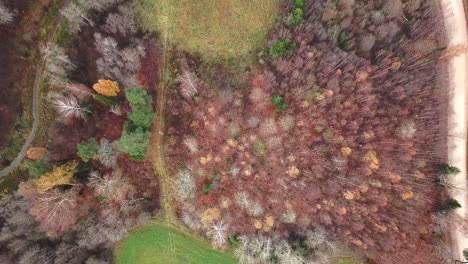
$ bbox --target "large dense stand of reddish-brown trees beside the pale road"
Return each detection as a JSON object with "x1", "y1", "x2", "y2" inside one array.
[{"x1": 165, "y1": 0, "x2": 444, "y2": 263}]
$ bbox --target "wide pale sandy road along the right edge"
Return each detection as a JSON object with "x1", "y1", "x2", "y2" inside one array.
[{"x1": 441, "y1": 0, "x2": 468, "y2": 260}]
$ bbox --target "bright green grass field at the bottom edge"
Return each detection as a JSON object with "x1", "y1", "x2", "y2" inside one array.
[{"x1": 116, "y1": 225, "x2": 238, "y2": 264}]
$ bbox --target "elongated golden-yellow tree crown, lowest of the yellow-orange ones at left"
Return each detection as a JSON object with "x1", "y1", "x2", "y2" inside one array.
[{"x1": 34, "y1": 161, "x2": 78, "y2": 192}]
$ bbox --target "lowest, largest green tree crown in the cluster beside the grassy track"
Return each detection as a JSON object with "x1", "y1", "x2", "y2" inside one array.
[{"x1": 117, "y1": 124, "x2": 150, "y2": 161}]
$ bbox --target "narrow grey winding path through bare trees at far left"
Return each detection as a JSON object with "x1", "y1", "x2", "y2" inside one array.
[{"x1": 0, "y1": 0, "x2": 71, "y2": 177}]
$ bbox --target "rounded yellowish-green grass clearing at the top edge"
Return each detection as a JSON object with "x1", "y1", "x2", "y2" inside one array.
[{"x1": 138, "y1": 0, "x2": 281, "y2": 61}]
